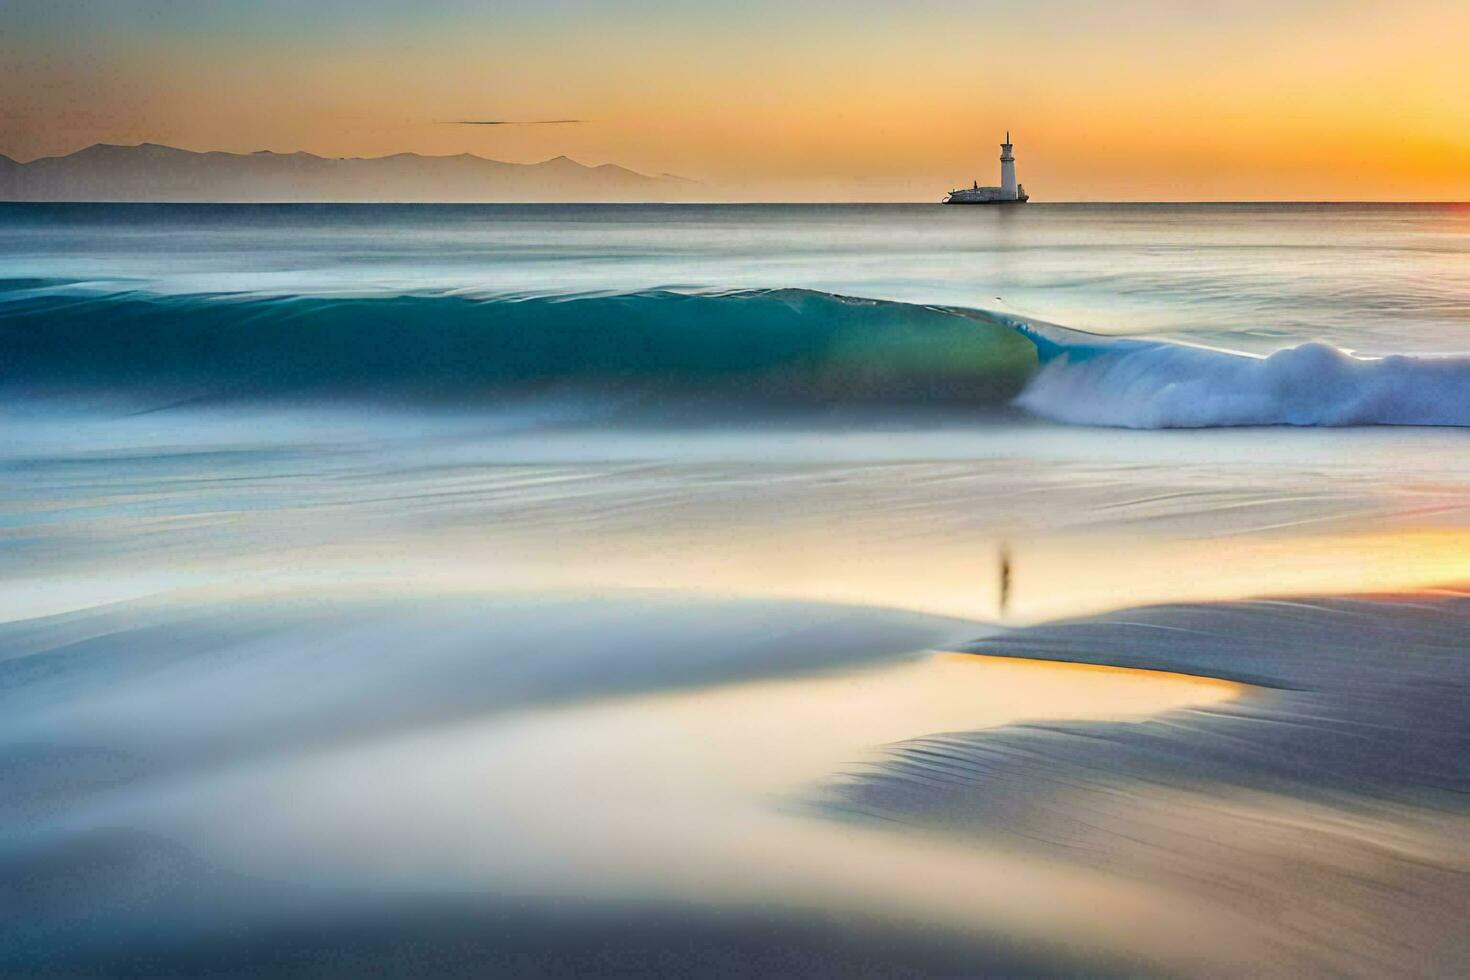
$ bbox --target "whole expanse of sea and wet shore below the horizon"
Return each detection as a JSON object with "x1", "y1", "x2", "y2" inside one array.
[{"x1": 0, "y1": 204, "x2": 1470, "y2": 977}]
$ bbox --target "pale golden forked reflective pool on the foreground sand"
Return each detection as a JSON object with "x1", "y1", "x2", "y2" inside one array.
[{"x1": 143, "y1": 643, "x2": 1241, "y2": 967}]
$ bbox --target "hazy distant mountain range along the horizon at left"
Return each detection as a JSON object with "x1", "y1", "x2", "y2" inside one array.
[{"x1": 0, "y1": 143, "x2": 703, "y2": 203}]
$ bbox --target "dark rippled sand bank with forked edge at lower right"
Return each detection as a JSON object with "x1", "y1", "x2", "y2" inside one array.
[{"x1": 833, "y1": 589, "x2": 1470, "y2": 976}]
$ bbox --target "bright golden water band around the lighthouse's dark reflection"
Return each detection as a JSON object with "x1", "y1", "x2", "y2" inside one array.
[{"x1": 231, "y1": 529, "x2": 1470, "y2": 628}]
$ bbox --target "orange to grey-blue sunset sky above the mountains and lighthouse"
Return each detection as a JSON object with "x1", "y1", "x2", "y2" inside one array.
[{"x1": 0, "y1": 0, "x2": 1470, "y2": 200}]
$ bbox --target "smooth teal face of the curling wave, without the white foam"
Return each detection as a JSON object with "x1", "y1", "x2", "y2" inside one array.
[{"x1": 0, "y1": 281, "x2": 1036, "y2": 404}]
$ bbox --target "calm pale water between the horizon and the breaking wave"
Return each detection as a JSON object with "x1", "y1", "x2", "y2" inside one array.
[{"x1": 0, "y1": 204, "x2": 1470, "y2": 354}]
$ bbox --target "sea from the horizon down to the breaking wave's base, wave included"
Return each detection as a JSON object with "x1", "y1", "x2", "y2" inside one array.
[{"x1": 0, "y1": 206, "x2": 1470, "y2": 428}]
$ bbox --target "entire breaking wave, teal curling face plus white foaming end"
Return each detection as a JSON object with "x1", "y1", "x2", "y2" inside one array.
[{"x1": 0, "y1": 279, "x2": 1470, "y2": 429}]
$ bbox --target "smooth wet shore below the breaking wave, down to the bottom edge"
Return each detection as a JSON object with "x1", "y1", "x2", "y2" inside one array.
[{"x1": 0, "y1": 423, "x2": 1470, "y2": 976}]
